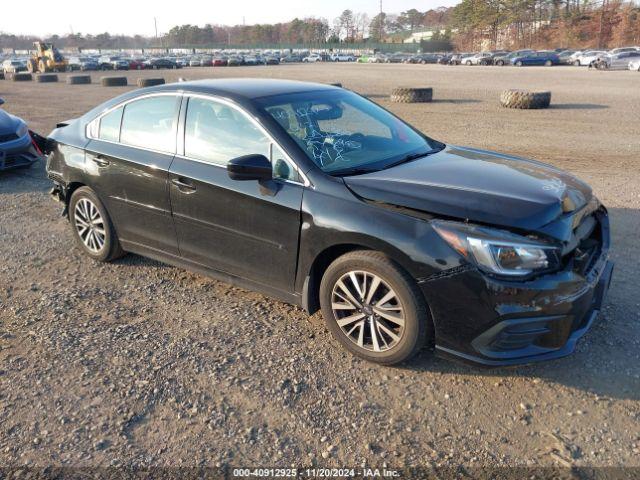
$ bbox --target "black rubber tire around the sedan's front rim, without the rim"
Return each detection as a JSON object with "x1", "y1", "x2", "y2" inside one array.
[{"x1": 320, "y1": 250, "x2": 433, "y2": 365}]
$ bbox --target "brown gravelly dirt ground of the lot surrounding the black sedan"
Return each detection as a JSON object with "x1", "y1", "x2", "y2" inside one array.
[{"x1": 0, "y1": 64, "x2": 640, "y2": 467}]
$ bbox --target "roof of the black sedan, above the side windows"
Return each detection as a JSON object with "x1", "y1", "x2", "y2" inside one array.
[{"x1": 147, "y1": 78, "x2": 336, "y2": 99}]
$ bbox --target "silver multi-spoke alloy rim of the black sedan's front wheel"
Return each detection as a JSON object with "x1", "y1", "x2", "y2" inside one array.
[{"x1": 331, "y1": 270, "x2": 405, "y2": 352}]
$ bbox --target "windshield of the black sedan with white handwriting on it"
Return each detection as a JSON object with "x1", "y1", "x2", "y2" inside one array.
[{"x1": 259, "y1": 90, "x2": 442, "y2": 175}]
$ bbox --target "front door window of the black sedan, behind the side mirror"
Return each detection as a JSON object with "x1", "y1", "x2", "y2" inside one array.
[{"x1": 184, "y1": 97, "x2": 298, "y2": 181}]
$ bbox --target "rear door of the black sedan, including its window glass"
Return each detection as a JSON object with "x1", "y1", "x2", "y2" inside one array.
[{"x1": 85, "y1": 93, "x2": 181, "y2": 255}]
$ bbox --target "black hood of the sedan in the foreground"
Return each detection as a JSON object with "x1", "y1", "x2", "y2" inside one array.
[{"x1": 344, "y1": 146, "x2": 593, "y2": 239}]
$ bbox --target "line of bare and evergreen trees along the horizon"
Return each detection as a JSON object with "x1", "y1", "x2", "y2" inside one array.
[{"x1": 0, "y1": 0, "x2": 640, "y2": 50}]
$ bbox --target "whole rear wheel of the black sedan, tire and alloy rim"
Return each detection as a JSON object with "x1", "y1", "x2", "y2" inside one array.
[{"x1": 69, "y1": 187, "x2": 124, "y2": 262}]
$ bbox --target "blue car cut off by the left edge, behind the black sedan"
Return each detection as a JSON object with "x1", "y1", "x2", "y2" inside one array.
[{"x1": 0, "y1": 98, "x2": 42, "y2": 172}]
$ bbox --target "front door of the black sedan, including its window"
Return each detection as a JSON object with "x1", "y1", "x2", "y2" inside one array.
[{"x1": 169, "y1": 96, "x2": 305, "y2": 292}]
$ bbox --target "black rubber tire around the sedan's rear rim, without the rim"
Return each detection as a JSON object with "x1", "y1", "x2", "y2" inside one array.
[{"x1": 69, "y1": 187, "x2": 125, "y2": 262}]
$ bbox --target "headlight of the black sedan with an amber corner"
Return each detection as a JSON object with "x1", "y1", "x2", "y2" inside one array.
[{"x1": 432, "y1": 220, "x2": 560, "y2": 276}]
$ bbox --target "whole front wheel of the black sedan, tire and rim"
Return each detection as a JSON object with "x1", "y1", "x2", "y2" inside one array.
[{"x1": 320, "y1": 251, "x2": 433, "y2": 365}]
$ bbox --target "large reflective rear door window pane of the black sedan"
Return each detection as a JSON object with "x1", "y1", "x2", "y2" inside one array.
[{"x1": 120, "y1": 95, "x2": 177, "y2": 153}]
